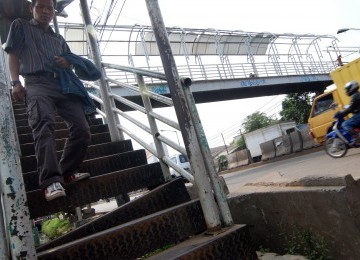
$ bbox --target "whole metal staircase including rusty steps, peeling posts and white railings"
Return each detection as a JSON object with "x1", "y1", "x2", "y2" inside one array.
[{"x1": 0, "y1": 0, "x2": 257, "y2": 259}]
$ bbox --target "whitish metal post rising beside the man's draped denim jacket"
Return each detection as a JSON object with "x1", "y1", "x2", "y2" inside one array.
[{"x1": 80, "y1": 0, "x2": 124, "y2": 141}]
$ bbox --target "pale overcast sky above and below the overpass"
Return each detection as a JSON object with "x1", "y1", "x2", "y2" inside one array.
[{"x1": 59, "y1": 0, "x2": 360, "y2": 146}]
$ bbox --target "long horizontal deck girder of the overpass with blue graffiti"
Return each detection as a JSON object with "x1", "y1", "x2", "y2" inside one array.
[{"x1": 105, "y1": 63, "x2": 334, "y2": 111}]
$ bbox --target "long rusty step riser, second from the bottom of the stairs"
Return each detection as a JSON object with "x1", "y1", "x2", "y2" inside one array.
[{"x1": 37, "y1": 200, "x2": 206, "y2": 260}]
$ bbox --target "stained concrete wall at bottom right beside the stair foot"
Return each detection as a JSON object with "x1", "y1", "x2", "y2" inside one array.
[{"x1": 229, "y1": 175, "x2": 360, "y2": 260}]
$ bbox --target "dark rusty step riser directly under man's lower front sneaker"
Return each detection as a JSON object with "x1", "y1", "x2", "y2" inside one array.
[{"x1": 26, "y1": 163, "x2": 165, "y2": 219}]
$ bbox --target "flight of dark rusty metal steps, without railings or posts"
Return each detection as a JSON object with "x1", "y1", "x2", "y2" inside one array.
[{"x1": 13, "y1": 100, "x2": 256, "y2": 259}]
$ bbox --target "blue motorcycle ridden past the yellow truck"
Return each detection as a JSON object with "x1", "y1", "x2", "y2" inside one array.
[{"x1": 324, "y1": 115, "x2": 360, "y2": 158}]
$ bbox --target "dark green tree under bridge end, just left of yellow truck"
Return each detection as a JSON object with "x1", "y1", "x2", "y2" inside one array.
[{"x1": 280, "y1": 92, "x2": 312, "y2": 124}]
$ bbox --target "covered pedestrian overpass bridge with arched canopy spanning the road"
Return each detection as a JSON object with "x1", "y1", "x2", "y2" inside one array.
[{"x1": 66, "y1": 24, "x2": 341, "y2": 111}]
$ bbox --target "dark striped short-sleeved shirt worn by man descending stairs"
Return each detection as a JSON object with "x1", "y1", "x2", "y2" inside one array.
[{"x1": 5, "y1": 18, "x2": 70, "y2": 75}]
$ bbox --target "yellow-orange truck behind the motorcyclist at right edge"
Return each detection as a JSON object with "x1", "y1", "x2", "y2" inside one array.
[{"x1": 308, "y1": 58, "x2": 360, "y2": 143}]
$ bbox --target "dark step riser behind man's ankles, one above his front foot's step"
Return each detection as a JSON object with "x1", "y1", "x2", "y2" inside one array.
[{"x1": 20, "y1": 140, "x2": 133, "y2": 173}]
